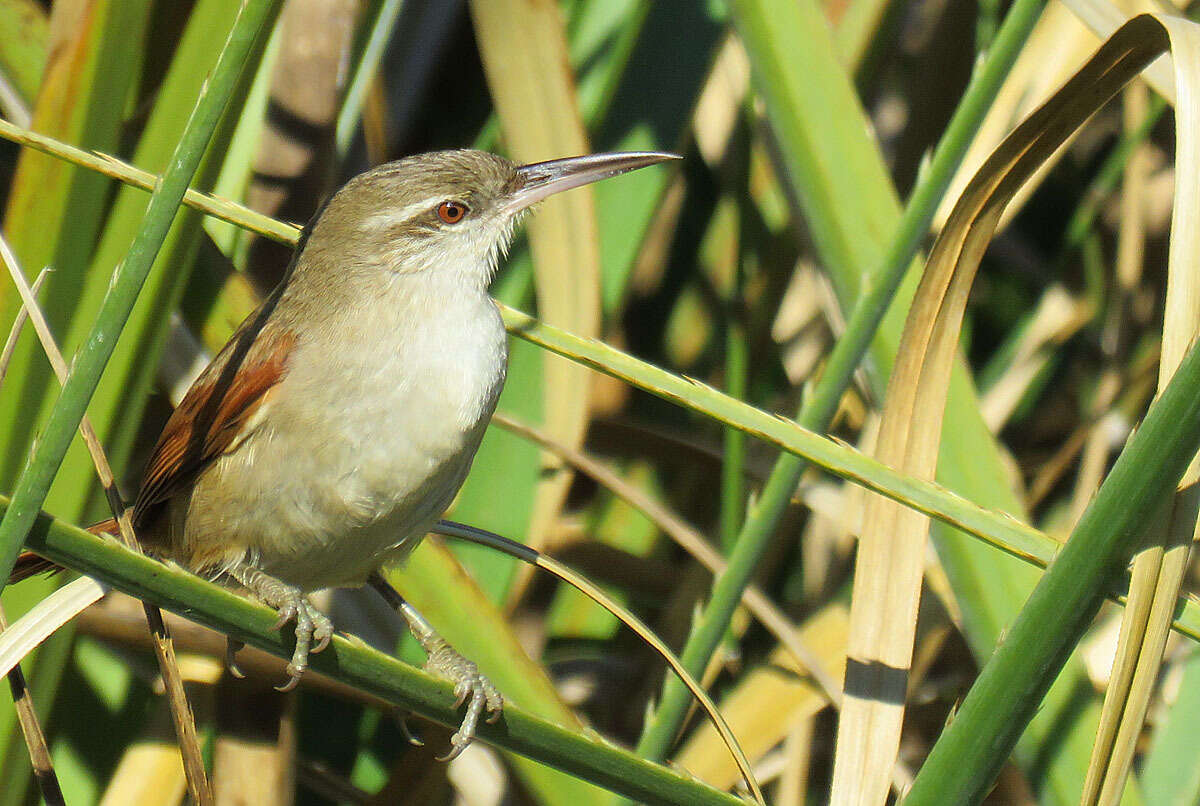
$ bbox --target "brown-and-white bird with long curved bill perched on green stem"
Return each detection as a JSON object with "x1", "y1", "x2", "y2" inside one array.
[{"x1": 14, "y1": 149, "x2": 678, "y2": 758}]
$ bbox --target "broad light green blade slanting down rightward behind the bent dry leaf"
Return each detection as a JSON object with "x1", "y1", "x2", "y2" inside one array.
[{"x1": 720, "y1": 4, "x2": 1123, "y2": 791}]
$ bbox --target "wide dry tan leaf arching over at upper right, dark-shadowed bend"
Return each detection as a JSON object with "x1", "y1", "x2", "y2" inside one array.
[{"x1": 832, "y1": 16, "x2": 1200, "y2": 804}]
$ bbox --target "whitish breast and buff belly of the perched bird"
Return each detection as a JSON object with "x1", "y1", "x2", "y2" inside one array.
[{"x1": 187, "y1": 286, "x2": 506, "y2": 590}]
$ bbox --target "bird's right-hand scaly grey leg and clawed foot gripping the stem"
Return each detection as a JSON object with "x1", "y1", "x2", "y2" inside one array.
[{"x1": 370, "y1": 573, "x2": 504, "y2": 762}]
